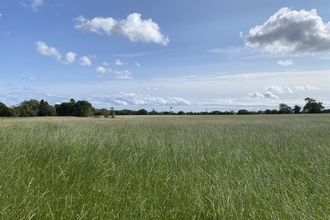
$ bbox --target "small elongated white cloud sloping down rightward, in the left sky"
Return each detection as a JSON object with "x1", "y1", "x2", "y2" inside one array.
[{"x1": 35, "y1": 41, "x2": 76, "y2": 64}]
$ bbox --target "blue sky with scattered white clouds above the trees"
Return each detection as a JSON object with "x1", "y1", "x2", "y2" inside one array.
[{"x1": 0, "y1": 0, "x2": 330, "y2": 112}]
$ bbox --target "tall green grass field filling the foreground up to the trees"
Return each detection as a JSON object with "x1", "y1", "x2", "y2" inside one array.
[{"x1": 0, "y1": 114, "x2": 330, "y2": 219}]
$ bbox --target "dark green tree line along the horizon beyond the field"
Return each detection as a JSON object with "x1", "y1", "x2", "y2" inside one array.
[{"x1": 0, "y1": 97, "x2": 330, "y2": 118}]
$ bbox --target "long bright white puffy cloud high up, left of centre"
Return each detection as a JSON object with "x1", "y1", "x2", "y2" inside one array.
[{"x1": 75, "y1": 13, "x2": 169, "y2": 46}]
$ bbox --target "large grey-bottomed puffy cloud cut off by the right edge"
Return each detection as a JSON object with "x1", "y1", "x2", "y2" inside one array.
[{"x1": 246, "y1": 8, "x2": 330, "y2": 54}]
